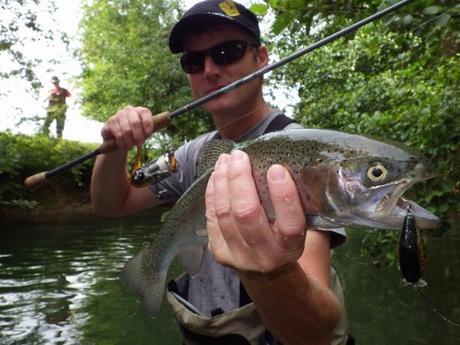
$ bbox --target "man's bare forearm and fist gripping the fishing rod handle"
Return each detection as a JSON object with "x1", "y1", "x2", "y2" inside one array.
[{"x1": 91, "y1": 107, "x2": 161, "y2": 217}]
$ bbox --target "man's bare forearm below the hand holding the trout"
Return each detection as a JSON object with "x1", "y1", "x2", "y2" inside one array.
[{"x1": 239, "y1": 230, "x2": 341, "y2": 345}]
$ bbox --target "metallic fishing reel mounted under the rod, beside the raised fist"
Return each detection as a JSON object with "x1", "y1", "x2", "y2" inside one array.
[{"x1": 130, "y1": 147, "x2": 178, "y2": 187}]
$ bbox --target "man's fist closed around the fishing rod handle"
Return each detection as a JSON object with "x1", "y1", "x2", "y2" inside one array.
[{"x1": 101, "y1": 106, "x2": 154, "y2": 150}]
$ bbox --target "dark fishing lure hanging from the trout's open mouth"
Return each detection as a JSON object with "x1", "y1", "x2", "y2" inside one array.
[{"x1": 398, "y1": 208, "x2": 427, "y2": 287}]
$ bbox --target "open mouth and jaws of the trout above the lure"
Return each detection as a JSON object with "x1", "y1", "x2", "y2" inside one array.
[{"x1": 375, "y1": 178, "x2": 441, "y2": 230}]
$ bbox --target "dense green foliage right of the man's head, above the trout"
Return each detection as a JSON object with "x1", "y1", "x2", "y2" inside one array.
[{"x1": 256, "y1": 0, "x2": 460, "y2": 261}]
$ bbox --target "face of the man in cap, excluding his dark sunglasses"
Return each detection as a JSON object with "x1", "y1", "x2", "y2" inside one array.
[{"x1": 184, "y1": 25, "x2": 268, "y2": 115}]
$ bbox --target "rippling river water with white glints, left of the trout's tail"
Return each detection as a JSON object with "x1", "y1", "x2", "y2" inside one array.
[{"x1": 0, "y1": 212, "x2": 180, "y2": 345}]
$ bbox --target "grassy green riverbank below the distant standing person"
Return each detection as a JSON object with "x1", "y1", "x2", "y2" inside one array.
[{"x1": 0, "y1": 132, "x2": 96, "y2": 209}]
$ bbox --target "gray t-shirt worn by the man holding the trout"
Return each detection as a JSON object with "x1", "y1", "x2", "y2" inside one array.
[{"x1": 151, "y1": 110, "x2": 346, "y2": 316}]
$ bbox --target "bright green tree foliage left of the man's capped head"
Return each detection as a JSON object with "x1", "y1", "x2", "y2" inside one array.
[{"x1": 81, "y1": 0, "x2": 212, "y2": 141}]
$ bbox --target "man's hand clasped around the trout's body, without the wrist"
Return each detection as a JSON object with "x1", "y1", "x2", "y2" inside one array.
[{"x1": 206, "y1": 151, "x2": 306, "y2": 273}]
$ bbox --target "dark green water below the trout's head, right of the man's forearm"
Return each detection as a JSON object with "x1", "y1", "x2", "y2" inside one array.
[{"x1": 333, "y1": 229, "x2": 460, "y2": 345}]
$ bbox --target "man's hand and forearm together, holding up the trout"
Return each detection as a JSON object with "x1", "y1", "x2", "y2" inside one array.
[{"x1": 206, "y1": 151, "x2": 341, "y2": 345}]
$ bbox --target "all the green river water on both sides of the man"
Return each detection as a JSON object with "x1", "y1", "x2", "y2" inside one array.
[{"x1": 0, "y1": 208, "x2": 460, "y2": 345}]
